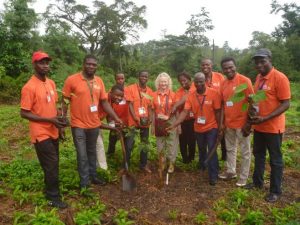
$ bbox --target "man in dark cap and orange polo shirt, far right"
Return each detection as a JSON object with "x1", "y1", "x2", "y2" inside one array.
[{"x1": 246, "y1": 49, "x2": 291, "y2": 202}]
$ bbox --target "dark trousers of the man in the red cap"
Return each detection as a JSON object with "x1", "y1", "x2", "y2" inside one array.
[{"x1": 34, "y1": 138, "x2": 60, "y2": 200}]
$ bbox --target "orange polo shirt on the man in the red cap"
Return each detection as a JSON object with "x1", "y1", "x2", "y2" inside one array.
[{"x1": 21, "y1": 75, "x2": 58, "y2": 143}]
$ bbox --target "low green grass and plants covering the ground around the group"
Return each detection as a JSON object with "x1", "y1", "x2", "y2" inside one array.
[{"x1": 0, "y1": 84, "x2": 300, "y2": 225}]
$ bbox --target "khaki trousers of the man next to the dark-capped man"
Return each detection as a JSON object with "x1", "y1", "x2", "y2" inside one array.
[{"x1": 225, "y1": 128, "x2": 251, "y2": 180}]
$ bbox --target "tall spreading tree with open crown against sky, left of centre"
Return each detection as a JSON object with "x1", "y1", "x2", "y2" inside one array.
[{"x1": 44, "y1": 0, "x2": 147, "y2": 57}]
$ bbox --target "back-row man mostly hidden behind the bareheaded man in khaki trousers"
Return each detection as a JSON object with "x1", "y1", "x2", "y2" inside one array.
[{"x1": 200, "y1": 59, "x2": 226, "y2": 160}]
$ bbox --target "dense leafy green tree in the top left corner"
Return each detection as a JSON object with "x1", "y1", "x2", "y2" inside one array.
[{"x1": 0, "y1": 0, "x2": 38, "y2": 77}]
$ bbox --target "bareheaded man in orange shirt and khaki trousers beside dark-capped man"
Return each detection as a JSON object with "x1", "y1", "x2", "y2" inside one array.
[{"x1": 219, "y1": 57, "x2": 253, "y2": 187}]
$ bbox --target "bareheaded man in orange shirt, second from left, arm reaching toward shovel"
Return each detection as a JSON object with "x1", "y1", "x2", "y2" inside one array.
[{"x1": 63, "y1": 55, "x2": 123, "y2": 190}]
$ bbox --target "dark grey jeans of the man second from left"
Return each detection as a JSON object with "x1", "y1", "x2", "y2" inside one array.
[{"x1": 72, "y1": 127, "x2": 99, "y2": 187}]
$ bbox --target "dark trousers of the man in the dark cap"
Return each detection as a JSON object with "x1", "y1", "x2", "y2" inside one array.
[{"x1": 253, "y1": 131, "x2": 283, "y2": 194}]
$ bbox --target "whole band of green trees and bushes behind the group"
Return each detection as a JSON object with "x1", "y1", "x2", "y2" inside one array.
[{"x1": 0, "y1": 0, "x2": 300, "y2": 103}]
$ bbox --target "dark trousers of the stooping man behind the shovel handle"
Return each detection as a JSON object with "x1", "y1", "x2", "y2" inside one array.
[{"x1": 107, "y1": 131, "x2": 134, "y2": 166}]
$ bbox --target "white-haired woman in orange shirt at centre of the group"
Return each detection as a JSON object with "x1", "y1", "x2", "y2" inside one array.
[{"x1": 153, "y1": 72, "x2": 178, "y2": 173}]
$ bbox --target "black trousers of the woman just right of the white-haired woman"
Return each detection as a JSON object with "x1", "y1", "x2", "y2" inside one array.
[{"x1": 179, "y1": 119, "x2": 196, "y2": 163}]
